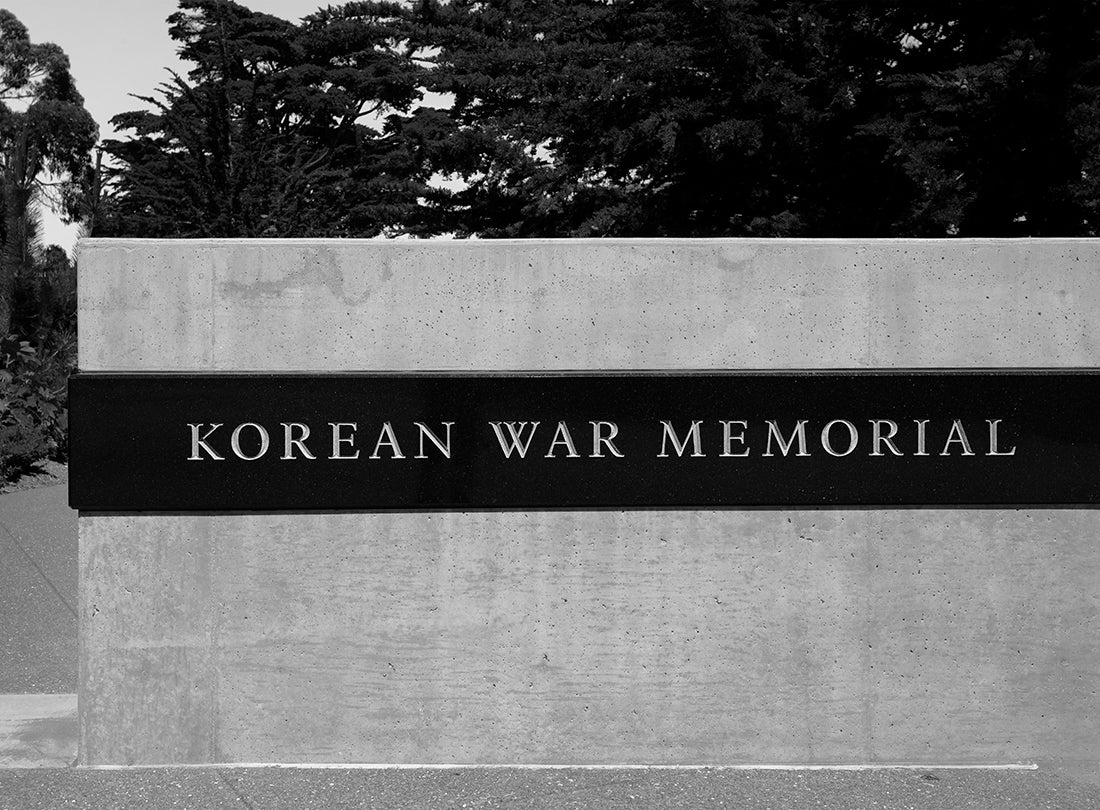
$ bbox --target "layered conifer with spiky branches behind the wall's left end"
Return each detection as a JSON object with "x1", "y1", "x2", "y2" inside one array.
[{"x1": 96, "y1": 0, "x2": 427, "y2": 237}]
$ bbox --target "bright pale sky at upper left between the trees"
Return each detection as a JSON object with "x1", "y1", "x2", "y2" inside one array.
[{"x1": 0, "y1": 0, "x2": 323, "y2": 250}]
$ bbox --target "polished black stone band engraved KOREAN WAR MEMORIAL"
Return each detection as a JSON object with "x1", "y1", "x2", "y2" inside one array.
[{"x1": 70, "y1": 371, "x2": 1100, "y2": 511}]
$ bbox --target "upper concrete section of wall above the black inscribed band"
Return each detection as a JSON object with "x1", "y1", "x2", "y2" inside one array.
[{"x1": 77, "y1": 239, "x2": 1100, "y2": 371}]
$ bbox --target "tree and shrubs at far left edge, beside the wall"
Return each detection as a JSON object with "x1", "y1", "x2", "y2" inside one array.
[{"x1": 0, "y1": 10, "x2": 89, "y2": 480}]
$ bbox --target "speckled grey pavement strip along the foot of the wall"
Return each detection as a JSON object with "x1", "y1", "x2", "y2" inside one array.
[{"x1": 0, "y1": 768, "x2": 1100, "y2": 810}]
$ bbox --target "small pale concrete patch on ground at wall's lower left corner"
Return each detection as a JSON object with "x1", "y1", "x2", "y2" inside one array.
[{"x1": 0, "y1": 694, "x2": 77, "y2": 768}]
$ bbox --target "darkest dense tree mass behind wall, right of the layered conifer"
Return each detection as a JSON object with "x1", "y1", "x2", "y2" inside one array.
[{"x1": 420, "y1": 0, "x2": 1100, "y2": 237}]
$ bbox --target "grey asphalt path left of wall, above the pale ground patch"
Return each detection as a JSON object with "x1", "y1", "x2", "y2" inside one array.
[{"x1": 0, "y1": 484, "x2": 77, "y2": 694}]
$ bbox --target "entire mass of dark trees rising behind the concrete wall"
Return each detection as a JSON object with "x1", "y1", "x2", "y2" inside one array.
[{"x1": 99, "y1": 0, "x2": 1100, "y2": 237}]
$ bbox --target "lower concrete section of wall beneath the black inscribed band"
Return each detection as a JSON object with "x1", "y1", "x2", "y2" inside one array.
[{"x1": 80, "y1": 510, "x2": 1100, "y2": 775}]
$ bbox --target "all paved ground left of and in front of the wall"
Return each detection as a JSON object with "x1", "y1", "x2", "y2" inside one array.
[{"x1": 0, "y1": 477, "x2": 1100, "y2": 810}]
